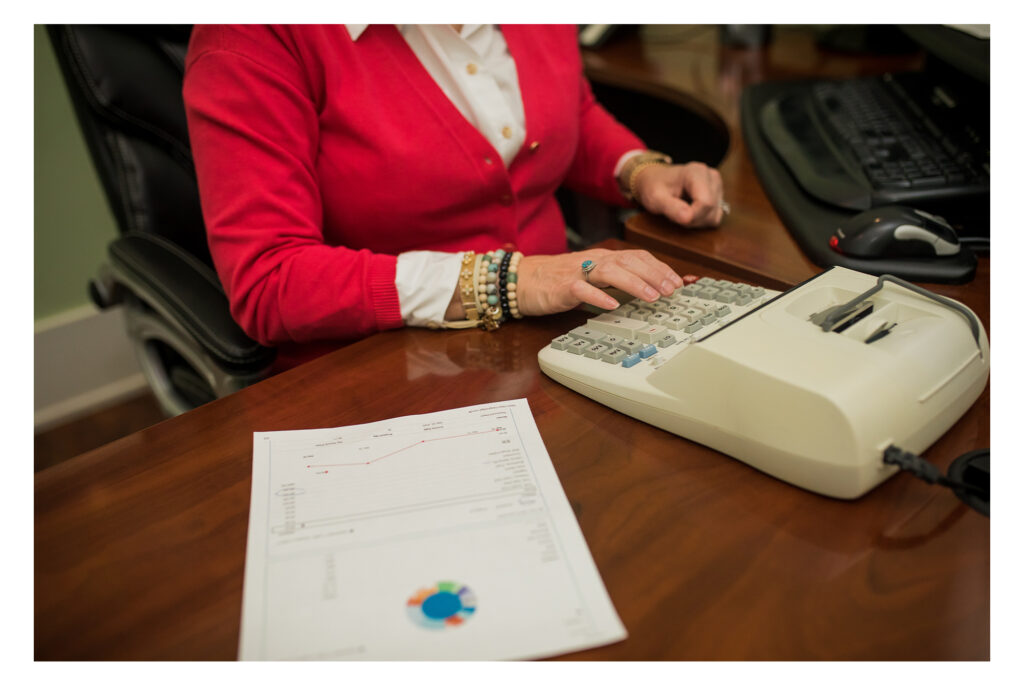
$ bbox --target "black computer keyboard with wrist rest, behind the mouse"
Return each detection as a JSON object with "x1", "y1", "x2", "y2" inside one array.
[{"x1": 760, "y1": 75, "x2": 989, "y2": 210}]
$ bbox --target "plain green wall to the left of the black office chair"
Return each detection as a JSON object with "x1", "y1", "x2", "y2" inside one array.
[{"x1": 33, "y1": 26, "x2": 117, "y2": 322}]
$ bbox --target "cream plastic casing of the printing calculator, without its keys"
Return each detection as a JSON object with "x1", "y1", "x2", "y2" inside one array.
[{"x1": 559, "y1": 266, "x2": 989, "y2": 499}]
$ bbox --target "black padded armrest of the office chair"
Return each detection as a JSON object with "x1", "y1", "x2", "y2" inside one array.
[{"x1": 109, "y1": 232, "x2": 275, "y2": 373}]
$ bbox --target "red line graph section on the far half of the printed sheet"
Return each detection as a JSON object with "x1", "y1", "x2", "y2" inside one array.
[{"x1": 269, "y1": 404, "x2": 543, "y2": 544}]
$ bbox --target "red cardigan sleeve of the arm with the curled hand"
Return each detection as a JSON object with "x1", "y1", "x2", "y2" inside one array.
[{"x1": 565, "y1": 70, "x2": 646, "y2": 207}]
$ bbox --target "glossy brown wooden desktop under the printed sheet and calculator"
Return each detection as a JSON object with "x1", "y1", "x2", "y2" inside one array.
[{"x1": 35, "y1": 243, "x2": 989, "y2": 659}]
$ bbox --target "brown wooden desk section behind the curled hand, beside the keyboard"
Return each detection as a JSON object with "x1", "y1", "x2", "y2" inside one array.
[{"x1": 584, "y1": 26, "x2": 989, "y2": 298}]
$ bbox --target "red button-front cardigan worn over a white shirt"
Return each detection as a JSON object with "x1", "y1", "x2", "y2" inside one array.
[{"x1": 184, "y1": 26, "x2": 643, "y2": 366}]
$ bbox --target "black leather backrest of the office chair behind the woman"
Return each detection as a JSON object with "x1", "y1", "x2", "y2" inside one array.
[{"x1": 47, "y1": 25, "x2": 210, "y2": 264}]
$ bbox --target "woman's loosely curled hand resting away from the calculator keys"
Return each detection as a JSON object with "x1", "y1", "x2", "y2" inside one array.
[{"x1": 635, "y1": 162, "x2": 727, "y2": 227}]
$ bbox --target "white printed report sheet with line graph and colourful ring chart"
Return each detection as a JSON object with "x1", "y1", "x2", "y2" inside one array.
[{"x1": 239, "y1": 399, "x2": 626, "y2": 660}]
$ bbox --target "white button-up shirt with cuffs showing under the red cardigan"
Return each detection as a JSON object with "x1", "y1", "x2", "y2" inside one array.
[{"x1": 345, "y1": 24, "x2": 635, "y2": 327}]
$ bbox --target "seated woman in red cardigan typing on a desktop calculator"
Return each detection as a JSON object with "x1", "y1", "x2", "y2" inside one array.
[{"x1": 184, "y1": 25, "x2": 724, "y2": 365}]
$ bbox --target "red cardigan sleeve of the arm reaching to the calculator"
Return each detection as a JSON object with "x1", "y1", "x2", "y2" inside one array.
[{"x1": 183, "y1": 27, "x2": 402, "y2": 345}]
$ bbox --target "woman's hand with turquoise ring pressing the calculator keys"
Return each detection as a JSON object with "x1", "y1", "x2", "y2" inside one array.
[{"x1": 516, "y1": 249, "x2": 683, "y2": 315}]
